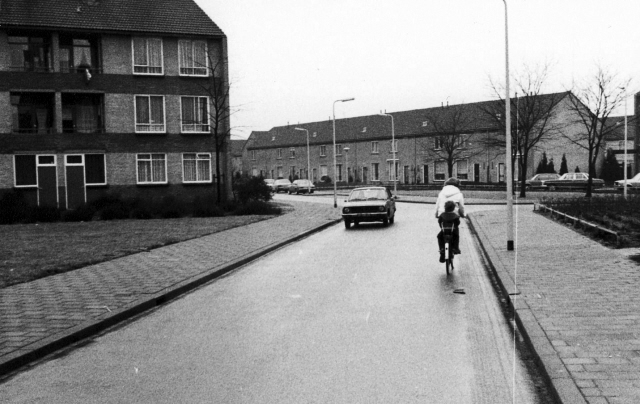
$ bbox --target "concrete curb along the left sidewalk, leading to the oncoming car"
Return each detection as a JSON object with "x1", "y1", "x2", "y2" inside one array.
[{"x1": 0, "y1": 219, "x2": 342, "y2": 376}]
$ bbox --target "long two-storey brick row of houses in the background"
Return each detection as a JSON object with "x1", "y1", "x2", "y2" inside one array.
[{"x1": 243, "y1": 93, "x2": 586, "y2": 185}]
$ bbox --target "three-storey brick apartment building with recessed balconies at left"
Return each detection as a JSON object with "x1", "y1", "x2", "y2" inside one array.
[{"x1": 0, "y1": 0, "x2": 230, "y2": 209}]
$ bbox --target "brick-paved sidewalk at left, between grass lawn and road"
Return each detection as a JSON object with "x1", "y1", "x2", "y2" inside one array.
[{"x1": 0, "y1": 202, "x2": 340, "y2": 375}]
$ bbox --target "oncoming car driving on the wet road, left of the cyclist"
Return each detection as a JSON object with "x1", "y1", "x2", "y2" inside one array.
[{"x1": 342, "y1": 187, "x2": 397, "y2": 229}]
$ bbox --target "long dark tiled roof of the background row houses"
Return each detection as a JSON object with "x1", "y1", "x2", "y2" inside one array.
[{"x1": 247, "y1": 92, "x2": 569, "y2": 149}]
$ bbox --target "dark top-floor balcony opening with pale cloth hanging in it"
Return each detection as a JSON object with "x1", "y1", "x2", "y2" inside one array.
[{"x1": 59, "y1": 34, "x2": 100, "y2": 73}]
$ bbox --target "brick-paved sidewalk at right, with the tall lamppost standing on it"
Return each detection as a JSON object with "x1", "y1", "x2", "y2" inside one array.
[{"x1": 471, "y1": 206, "x2": 640, "y2": 404}]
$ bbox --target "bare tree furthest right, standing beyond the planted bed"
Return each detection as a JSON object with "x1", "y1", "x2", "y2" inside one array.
[{"x1": 565, "y1": 65, "x2": 631, "y2": 197}]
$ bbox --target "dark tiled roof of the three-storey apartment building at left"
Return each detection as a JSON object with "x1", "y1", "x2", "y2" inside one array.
[{"x1": 0, "y1": 0, "x2": 224, "y2": 36}]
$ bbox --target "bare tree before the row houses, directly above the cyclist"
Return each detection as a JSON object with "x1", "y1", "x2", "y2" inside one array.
[{"x1": 421, "y1": 105, "x2": 482, "y2": 177}]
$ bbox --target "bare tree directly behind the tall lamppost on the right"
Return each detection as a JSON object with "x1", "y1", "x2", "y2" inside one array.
[{"x1": 478, "y1": 63, "x2": 569, "y2": 197}]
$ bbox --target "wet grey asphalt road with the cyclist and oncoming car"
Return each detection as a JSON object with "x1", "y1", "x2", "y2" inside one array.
[{"x1": 0, "y1": 196, "x2": 545, "y2": 403}]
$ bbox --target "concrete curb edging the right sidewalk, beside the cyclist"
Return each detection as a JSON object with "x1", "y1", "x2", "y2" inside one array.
[{"x1": 469, "y1": 215, "x2": 587, "y2": 404}]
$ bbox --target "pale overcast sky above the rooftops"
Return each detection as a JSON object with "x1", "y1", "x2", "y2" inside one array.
[{"x1": 195, "y1": 0, "x2": 640, "y2": 139}]
